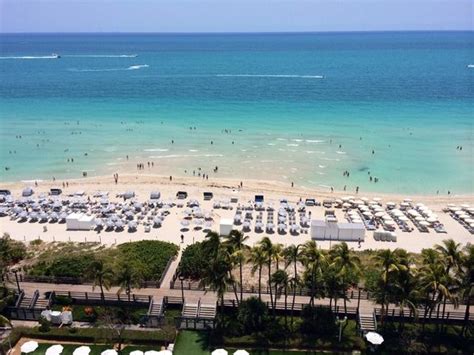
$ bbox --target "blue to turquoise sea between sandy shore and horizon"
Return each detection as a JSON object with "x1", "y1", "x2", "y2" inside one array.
[{"x1": 0, "y1": 32, "x2": 474, "y2": 194}]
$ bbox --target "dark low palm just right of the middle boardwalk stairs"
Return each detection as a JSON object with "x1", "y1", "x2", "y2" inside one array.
[{"x1": 200, "y1": 253, "x2": 235, "y2": 322}]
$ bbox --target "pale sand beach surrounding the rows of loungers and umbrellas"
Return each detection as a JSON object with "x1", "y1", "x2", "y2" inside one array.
[{"x1": 0, "y1": 174, "x2": 474, "y2": 252}]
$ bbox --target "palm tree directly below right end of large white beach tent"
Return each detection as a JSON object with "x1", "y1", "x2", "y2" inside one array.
[{"x1": 329, "y1": 242, "x2": 360, "y2": 313}]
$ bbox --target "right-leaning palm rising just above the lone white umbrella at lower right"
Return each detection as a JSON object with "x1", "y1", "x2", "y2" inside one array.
[{"x1": 374, "y1": 248, "x2": 407, "y2": 324}]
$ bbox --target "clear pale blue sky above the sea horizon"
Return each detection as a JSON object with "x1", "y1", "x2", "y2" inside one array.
[{"x1": 0, "y1": 0, "x2": 474, "y2": 33}]
